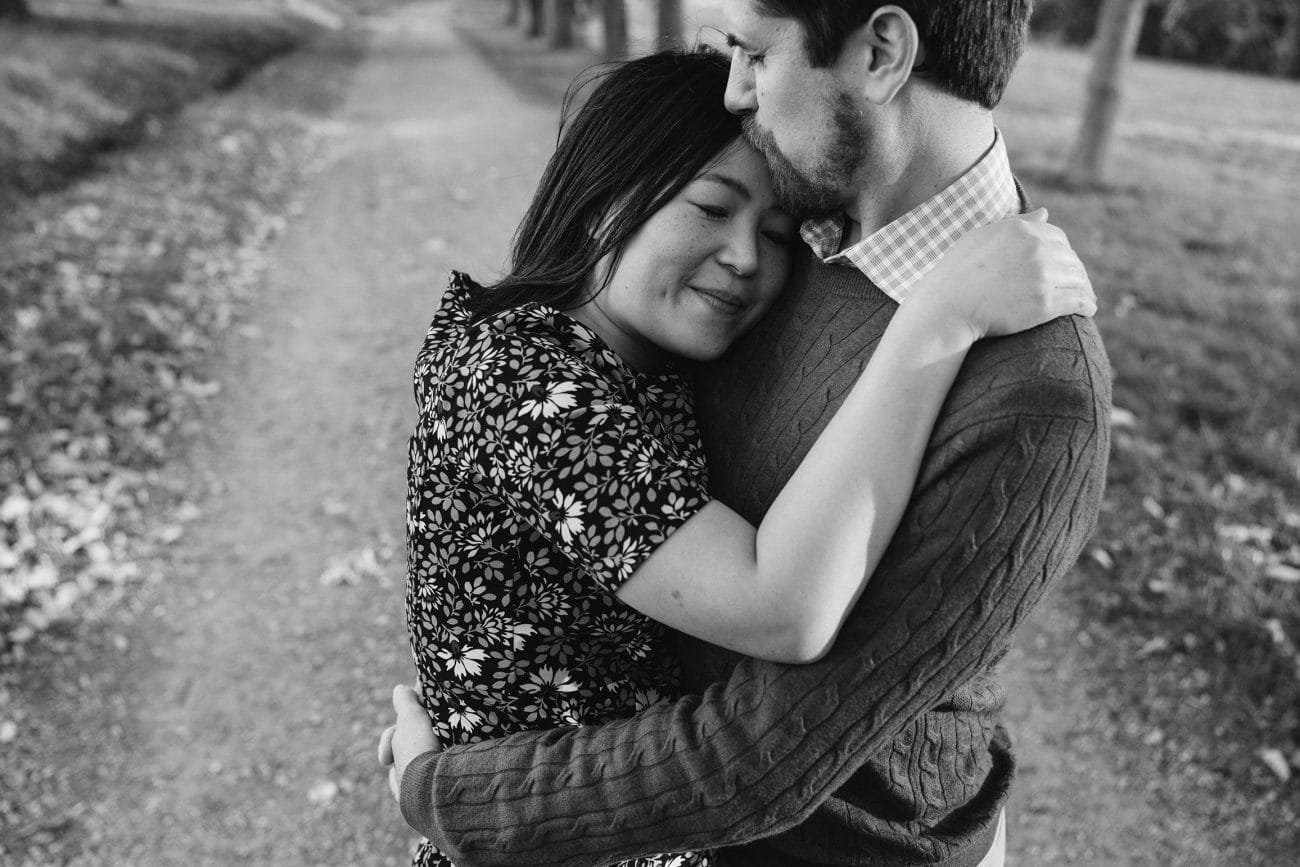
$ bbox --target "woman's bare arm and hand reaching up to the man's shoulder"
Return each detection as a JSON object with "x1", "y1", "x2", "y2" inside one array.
[{"x1": 618, "y1": 217, "x2": 1096, "y2": 662}]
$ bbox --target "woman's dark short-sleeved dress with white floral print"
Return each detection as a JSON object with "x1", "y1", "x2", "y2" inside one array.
[{"x1": 407, "y1": 273, "x2": 711, "y2": 867}]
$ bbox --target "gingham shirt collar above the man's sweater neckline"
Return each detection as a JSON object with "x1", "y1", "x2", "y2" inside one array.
[{"x1": 800, "y1": 129, "x2": 1021, "y2": 303}]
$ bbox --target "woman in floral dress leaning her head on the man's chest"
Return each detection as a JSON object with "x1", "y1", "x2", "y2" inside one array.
[{"x1": 381, "y1": 53, "x2": 1092, "y2": 866}]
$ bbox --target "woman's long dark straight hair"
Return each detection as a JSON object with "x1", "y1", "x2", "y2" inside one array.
[{"x1": 469, "y1": 51, "x2": 741, "y2": 317}]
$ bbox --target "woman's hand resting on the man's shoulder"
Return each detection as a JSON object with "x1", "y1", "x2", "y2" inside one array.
[{"x1": 902, "y1": 208, "x2": 1097, "y2": 342}]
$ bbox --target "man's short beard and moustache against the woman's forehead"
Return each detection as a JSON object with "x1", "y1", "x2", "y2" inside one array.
[{"x1": 741, "y1": 94, "x2": 867, "y2": 220}]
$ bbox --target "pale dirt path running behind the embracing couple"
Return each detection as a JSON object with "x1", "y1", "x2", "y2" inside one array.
[{"x1": 7, "y1": 1, "x2": 1214, "y2": 867}]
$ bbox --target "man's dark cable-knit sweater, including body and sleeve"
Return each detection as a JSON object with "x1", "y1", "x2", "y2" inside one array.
[{"x1": 402, "y1": 246, "x2": 1110, "y2": 867}]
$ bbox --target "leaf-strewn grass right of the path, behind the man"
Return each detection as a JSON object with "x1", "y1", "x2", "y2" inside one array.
[{"x1": 463, "y1": 3, "x2": 1300, "y2": 863}]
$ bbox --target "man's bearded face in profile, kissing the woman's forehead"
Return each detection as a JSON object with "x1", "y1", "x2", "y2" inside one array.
[{"x1": 723, "y1": 0, "x2": 870, "y2": 217}]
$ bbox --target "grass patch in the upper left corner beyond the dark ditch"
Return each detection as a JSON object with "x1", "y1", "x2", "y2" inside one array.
[{"x1": 0, "y1": 3, "x2": 312, "y2": 195}]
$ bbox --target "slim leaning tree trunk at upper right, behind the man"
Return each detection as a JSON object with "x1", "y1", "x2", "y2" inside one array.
[{"x1": 1066, "y1": 0, "x2": 1147, "y2": 186}]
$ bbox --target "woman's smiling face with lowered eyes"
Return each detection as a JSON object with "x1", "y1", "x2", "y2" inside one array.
[{"x1": 571, "y1": 142, "x2": 796, "y2": 369}]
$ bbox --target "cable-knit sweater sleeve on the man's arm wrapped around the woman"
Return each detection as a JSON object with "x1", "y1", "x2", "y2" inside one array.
[{"x1": 402, "y1": 321, "x2": 1109, "y2": 867}]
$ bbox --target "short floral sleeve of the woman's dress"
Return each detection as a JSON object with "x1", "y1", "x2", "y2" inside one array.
[{"x1": 421, "y1": 328, "x2": 709, "y2": 593}]
